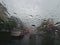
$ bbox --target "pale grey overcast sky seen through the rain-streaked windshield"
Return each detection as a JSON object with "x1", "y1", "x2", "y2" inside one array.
[{"x1": 0, "y1": 0, "x2": 60, "y2": 29}]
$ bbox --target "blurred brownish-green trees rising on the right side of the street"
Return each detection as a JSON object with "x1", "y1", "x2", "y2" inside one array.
[{"x1": 37, "y1": 18, "x2": 54, "y2": 32}]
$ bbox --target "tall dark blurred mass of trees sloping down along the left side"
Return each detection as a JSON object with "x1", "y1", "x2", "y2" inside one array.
[{"x1": 0, "y1": 3, "x2": 23, "y2": 30}]
